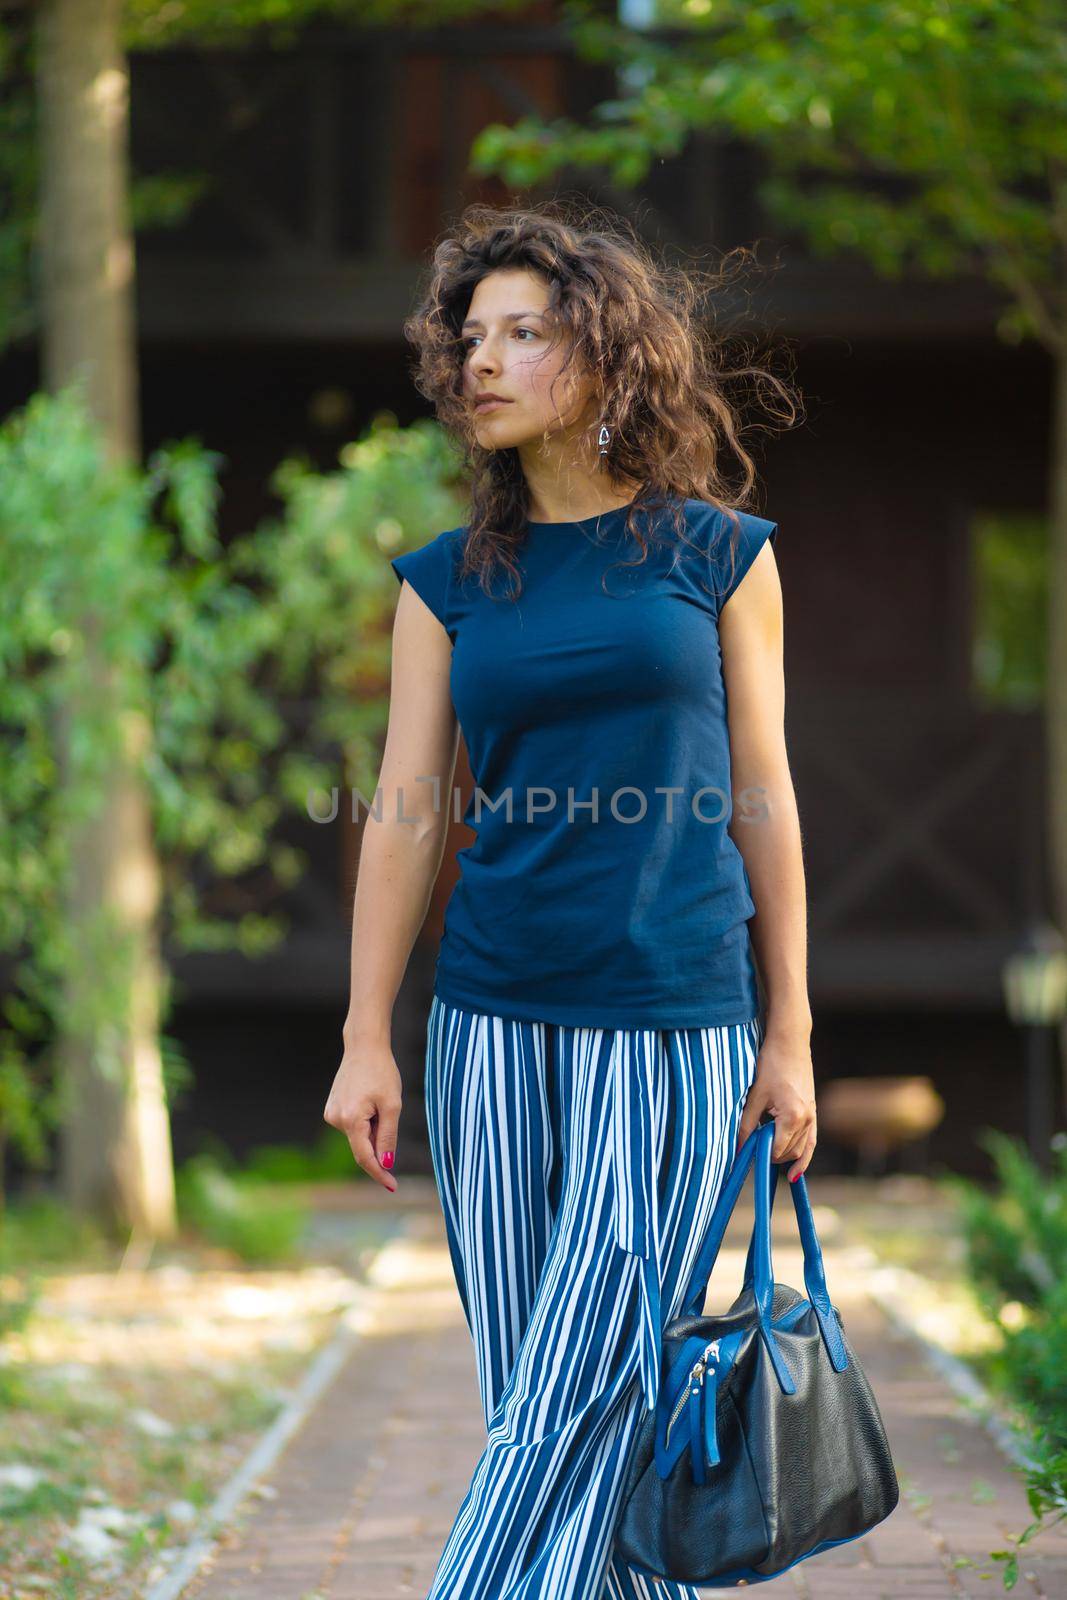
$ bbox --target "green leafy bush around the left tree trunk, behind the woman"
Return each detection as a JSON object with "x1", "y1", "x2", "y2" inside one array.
[{"x1": 0, "y1": 389, "x2": 459, "y2": 1203}]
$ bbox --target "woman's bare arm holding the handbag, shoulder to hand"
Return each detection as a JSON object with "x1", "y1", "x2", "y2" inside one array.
[{"x1": 718, "y1": 542, "x2": 816, "y2": 1181}]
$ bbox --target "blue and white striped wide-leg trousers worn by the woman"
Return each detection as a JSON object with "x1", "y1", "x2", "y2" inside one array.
[{"x1": 426, "y1": 995, "x2": 763, "y2": 1600}]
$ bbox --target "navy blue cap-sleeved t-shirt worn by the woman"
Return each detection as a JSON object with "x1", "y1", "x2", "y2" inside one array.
[{"x1": 392, "y1": 499, "x2": 777, "y2": 1029}]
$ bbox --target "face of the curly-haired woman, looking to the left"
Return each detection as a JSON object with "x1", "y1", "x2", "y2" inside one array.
[{"x1": 462, "y1": 267, "x2": 592, "y2": 450}]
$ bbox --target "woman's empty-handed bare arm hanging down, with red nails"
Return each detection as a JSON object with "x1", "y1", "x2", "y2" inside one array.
[{"x1": 323, "y1": 582, "x2": 459, "y2": 1190}]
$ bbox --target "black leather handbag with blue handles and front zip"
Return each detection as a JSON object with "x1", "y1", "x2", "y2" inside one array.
[{"x1": 614, "y1": 1122, "x2": 899, "y2": 1587}]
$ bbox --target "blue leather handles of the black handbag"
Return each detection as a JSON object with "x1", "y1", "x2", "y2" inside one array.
[{"x1": 683, "y1": 1120, "x2": 848, "y2": 1394}]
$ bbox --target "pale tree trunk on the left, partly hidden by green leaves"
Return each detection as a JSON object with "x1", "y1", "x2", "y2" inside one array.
[{"x1": 37, "y1": 0, "x2": 174, "y2": 1238}]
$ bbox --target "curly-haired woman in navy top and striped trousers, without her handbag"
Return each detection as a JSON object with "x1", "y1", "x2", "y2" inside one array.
[{"x1": 325, "y1": 206, "x2": 816, "y2": 1600}]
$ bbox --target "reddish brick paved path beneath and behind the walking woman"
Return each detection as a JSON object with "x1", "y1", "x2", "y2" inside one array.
[{"x1": 182, "y1": 1178, "x2": 1067, "y2": 1600}]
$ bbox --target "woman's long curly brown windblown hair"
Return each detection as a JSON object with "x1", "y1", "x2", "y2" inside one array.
[{"x1": 403, "y1": 200, "x2": 801, "y2": 594}]
